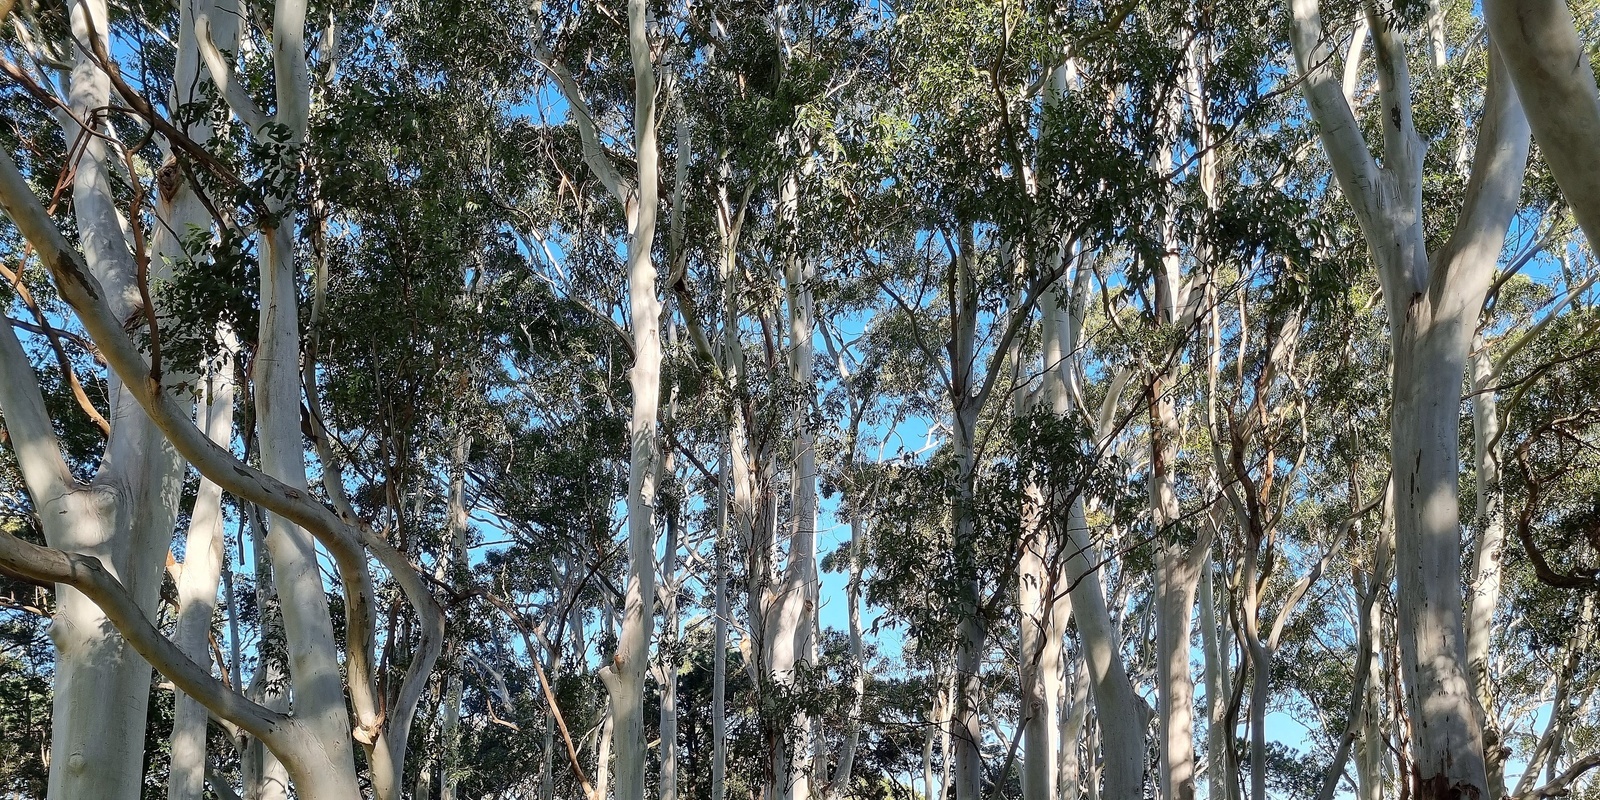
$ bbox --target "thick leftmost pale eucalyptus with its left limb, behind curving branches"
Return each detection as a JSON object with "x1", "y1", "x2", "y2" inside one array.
[{"x1": 0, "y1": 3, "x2": 216, "y2": 797}]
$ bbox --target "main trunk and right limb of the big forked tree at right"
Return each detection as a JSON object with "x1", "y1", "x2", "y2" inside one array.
[{"x1": 1386, "y1": 50, "x2": 1528, "y2": 798}]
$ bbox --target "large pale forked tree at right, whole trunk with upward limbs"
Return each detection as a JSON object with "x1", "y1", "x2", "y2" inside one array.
[{"x1": 1290, "y1": 0, "x2": 1523, "y2": 800}]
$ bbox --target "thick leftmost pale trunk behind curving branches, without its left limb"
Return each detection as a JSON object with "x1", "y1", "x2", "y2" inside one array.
[{"x1": 43, "y1": 0, "x2": 182, "y2": 800}]
